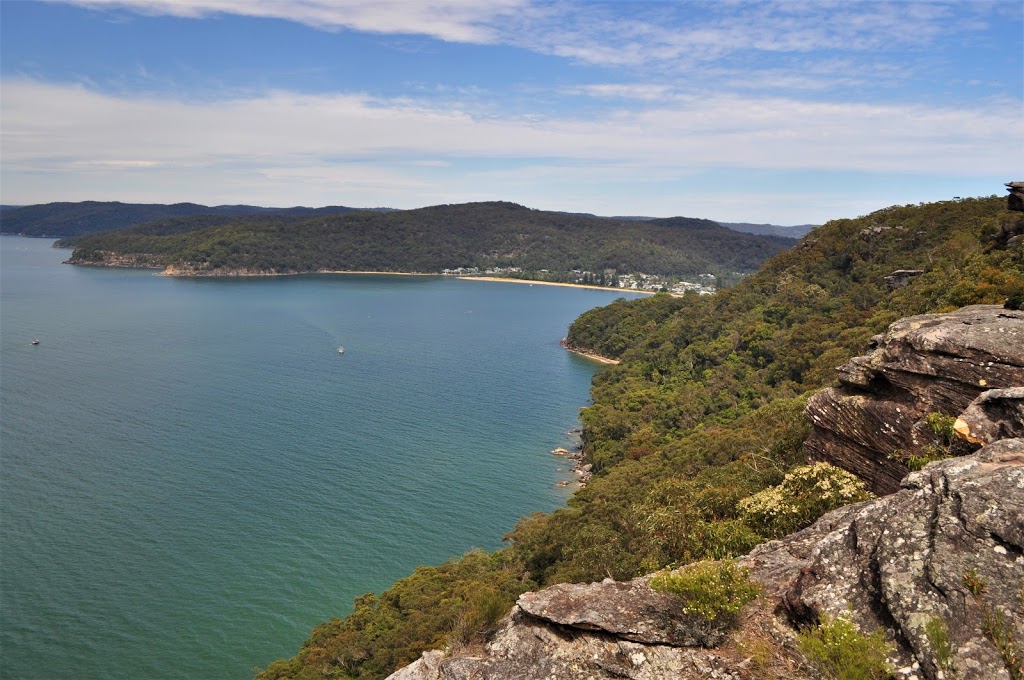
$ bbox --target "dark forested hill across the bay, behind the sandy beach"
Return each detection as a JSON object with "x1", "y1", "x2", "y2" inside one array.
[{"x1": 59, "y1": 203, "x2": 795, "y2": 275}]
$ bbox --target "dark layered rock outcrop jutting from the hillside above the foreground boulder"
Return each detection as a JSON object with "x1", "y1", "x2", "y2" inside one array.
[{"x1": 806, "y1": 305, "x2": 1024, "y2": 494}]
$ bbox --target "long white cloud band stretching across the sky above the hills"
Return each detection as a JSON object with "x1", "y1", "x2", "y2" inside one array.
[{"x1": 2, "y1": 81, "x2": 1021, "y2": 174}]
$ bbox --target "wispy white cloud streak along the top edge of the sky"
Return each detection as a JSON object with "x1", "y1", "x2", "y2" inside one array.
[{"x1": 49, "y1": 0, "x2": 999, "y2": 73}]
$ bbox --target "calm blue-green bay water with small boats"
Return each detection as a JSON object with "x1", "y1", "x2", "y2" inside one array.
[{"x1": 0, "y1": 237, "x2": 638, "y2": 678}]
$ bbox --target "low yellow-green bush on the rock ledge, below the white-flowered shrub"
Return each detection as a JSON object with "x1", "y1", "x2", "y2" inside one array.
[{"x1": 649, "y1": 560, "x2": 761, "y2": 622}]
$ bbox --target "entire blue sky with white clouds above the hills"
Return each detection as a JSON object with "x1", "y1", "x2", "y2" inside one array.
[{"x1": 0, "y1": 0, "x2": 1024, "y2": 224}]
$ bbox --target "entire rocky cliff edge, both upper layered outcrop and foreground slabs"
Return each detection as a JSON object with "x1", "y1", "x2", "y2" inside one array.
[{"x1": 391, "y1": 307, "x2": 1024, "y2": 680}]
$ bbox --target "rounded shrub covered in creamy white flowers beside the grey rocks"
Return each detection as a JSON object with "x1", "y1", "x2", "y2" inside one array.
[{"x1": 739, "y1": 463, "x2": 874, "y2": 539}]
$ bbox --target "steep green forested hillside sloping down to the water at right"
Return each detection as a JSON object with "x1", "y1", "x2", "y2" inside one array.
[{"x1": 258, "y1": 197, "x2": 1024, "y2": 679}]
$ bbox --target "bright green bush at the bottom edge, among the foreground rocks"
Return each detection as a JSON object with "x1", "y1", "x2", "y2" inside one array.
[{"x1": 797, "y1": 617, "x2": 893, "y2": 680}]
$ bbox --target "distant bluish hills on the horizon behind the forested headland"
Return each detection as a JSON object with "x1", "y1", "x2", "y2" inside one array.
[{"x1": 0, "y1": 201, "x2": 817, "y2": 239}]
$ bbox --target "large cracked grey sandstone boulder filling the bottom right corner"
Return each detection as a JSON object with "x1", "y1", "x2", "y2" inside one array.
[{"x1": 744, "y1": 439, "x2": 1024, "y2": 680}]
